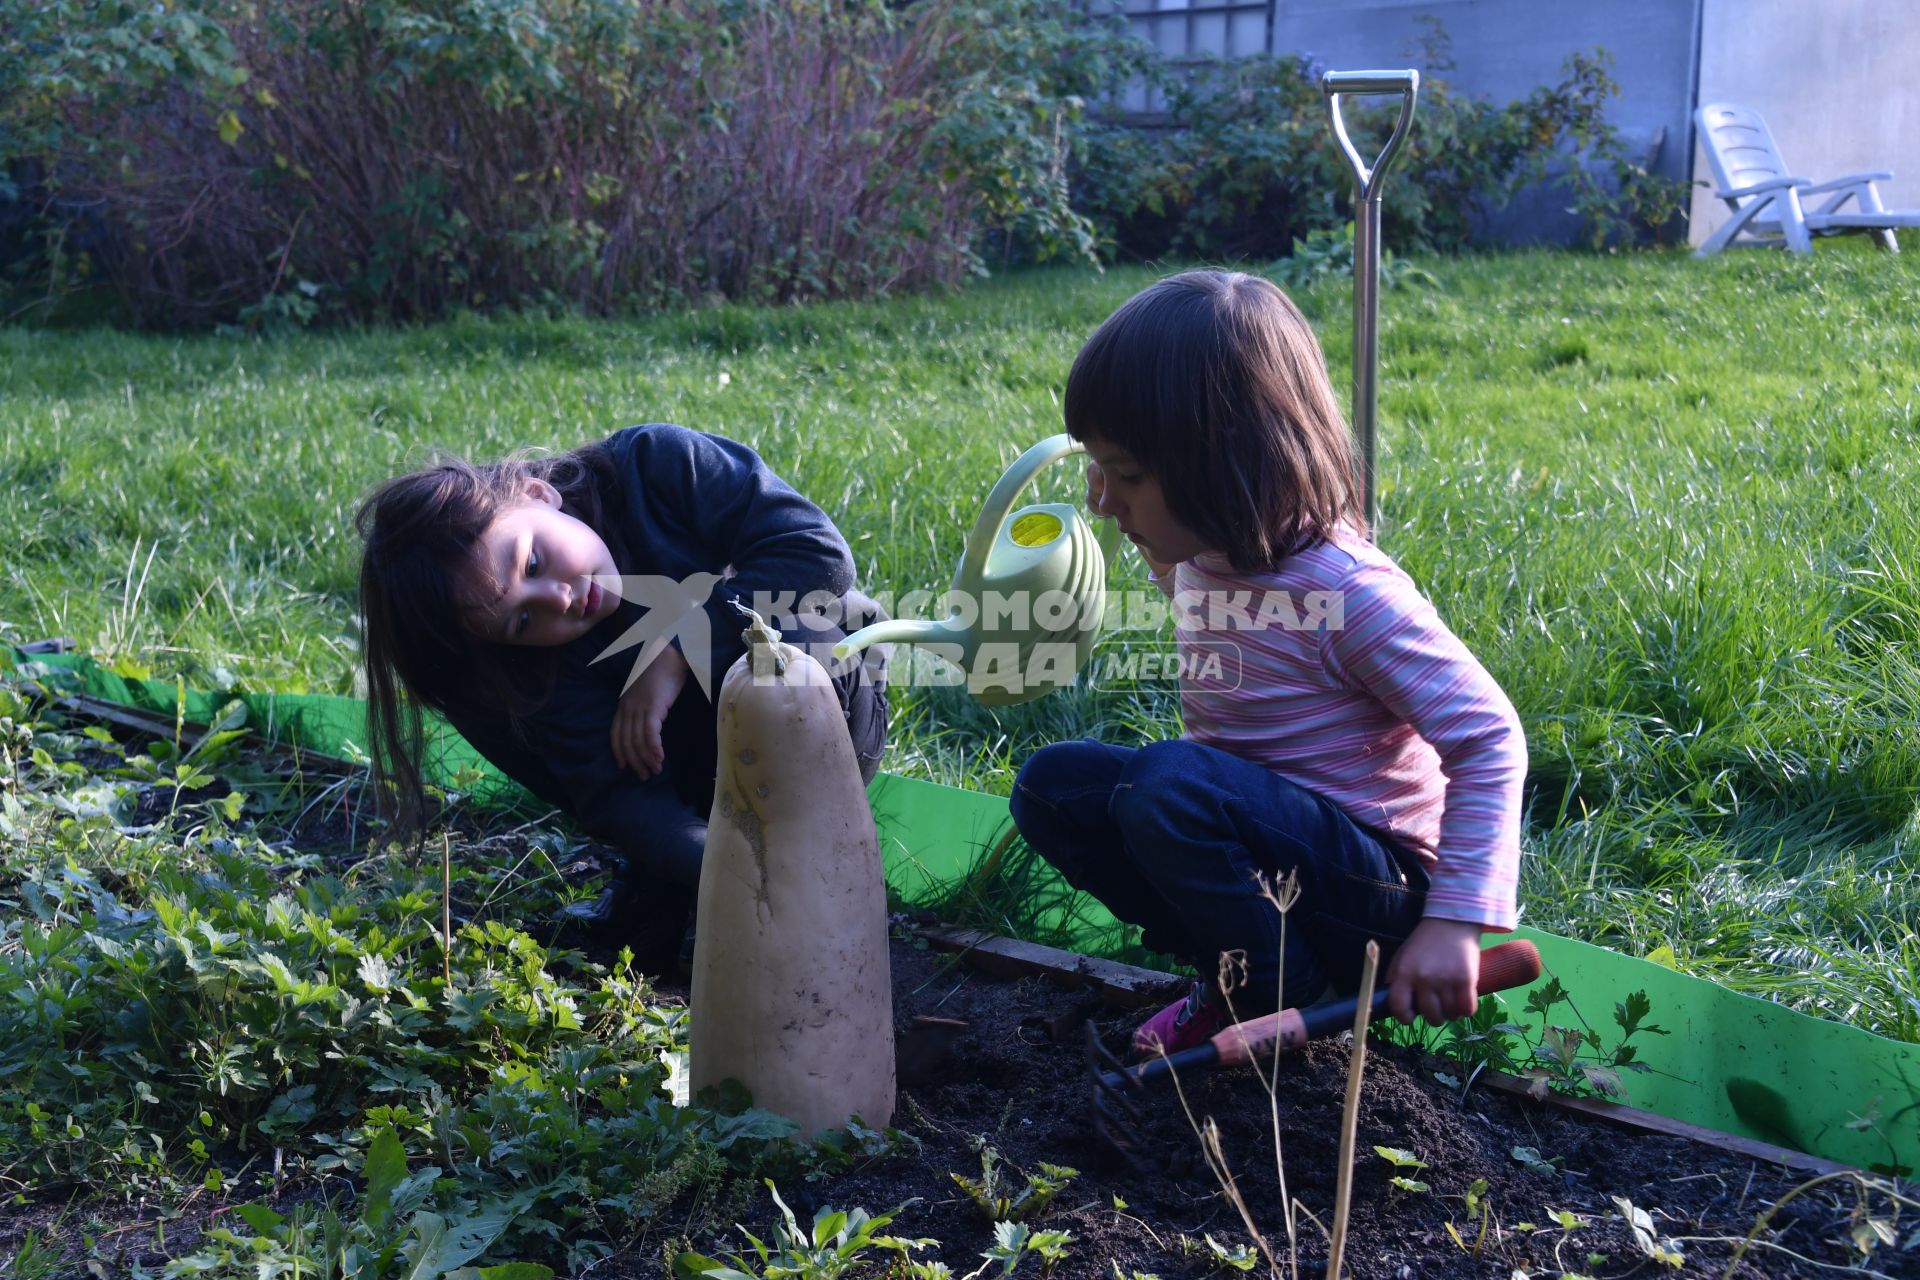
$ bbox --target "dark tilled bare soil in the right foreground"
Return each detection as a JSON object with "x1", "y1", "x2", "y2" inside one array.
[{"x1": 641, "y1": 944, "x2": 1920, "y2": 1280}]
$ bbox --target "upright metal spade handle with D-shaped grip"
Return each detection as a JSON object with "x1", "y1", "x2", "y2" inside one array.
[{"x1": 1321, "y1": 69, "x2": 1421, "y2": 537}]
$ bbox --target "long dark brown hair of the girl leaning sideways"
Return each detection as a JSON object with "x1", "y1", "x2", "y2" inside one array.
[{"x1": 353, "y1": 445, "x2": 620, "y2": 837}]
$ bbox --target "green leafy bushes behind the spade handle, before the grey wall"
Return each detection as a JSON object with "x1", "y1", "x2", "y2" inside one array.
[{"x1": 1075, "y1": 25, "x2": 1686, "y2": 259}]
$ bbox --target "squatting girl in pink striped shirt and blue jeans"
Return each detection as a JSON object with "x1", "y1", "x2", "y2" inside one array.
[{"x1": 1012, "y1": 271, "x2": 1526, "y2": 1055}]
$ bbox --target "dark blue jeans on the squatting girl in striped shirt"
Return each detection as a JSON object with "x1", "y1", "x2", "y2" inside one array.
[{"x1": 1012, "y1": 739, "x2": 1428, "y2": 1015}]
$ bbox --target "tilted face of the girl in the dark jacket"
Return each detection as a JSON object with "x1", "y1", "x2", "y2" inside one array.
[{"x1": 467, "y1": 480, "x2": 620, "y2": 645}]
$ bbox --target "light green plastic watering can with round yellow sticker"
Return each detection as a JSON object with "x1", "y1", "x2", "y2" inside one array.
[{"x1": 833, "y1": 434, "x2": 1119, "y2": 706}]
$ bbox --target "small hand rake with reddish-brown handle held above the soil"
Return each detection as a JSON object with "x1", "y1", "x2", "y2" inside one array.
[{"x1": 1087, "y1": 938, "x2": 1540, "y2": 1165}]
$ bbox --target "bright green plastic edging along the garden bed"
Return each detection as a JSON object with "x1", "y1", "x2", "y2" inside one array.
[{"x1": 15, "y1": 651, "x2": 1920, "y2": 1176}]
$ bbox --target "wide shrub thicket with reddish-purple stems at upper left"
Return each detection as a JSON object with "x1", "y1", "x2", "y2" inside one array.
[{"x1": 0, "y1": 0, "x2": 1128, "y2": 324}]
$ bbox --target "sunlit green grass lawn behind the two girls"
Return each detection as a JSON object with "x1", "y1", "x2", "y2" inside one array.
[{"x1": 0, "y1": 244, "x2": 1920, "y2": 1040}]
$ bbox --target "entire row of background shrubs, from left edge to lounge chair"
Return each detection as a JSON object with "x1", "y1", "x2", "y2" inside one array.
[{"x1": 0, "y1": 0, "x2": 1680, "y2": 328}]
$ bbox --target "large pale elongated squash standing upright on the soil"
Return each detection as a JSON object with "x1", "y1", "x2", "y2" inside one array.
[{"x1": 689, "y1": 618, "x2": 893, "y2": 1136}]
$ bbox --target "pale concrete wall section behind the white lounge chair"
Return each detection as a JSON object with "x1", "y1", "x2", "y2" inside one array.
[{"x1": 1690, "y1": 0, "x2": 1920, "y2": 244}]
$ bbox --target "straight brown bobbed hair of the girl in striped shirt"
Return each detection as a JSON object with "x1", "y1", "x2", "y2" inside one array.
[{"x1": 1064, "y1": 271, "x2": 1367, "y2": 572}]
